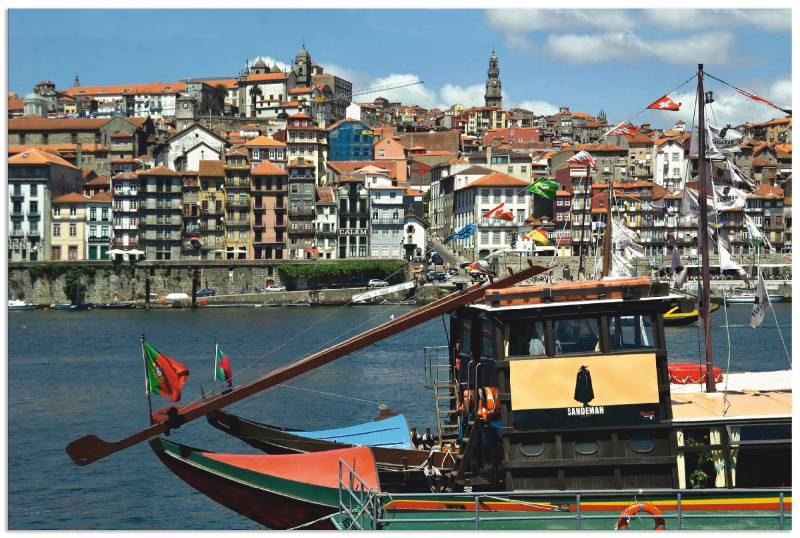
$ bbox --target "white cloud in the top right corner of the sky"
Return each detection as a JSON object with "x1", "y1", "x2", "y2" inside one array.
[{"x1": 642, "y1": 9, "x2": 792, "y2": 32}]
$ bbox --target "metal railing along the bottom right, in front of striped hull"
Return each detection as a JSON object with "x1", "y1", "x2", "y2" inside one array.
[{"x1": 354, "y1": 486, "x2": 792, "y2": 530}]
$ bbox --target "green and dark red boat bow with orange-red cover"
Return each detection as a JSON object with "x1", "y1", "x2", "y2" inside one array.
[{"x1": 150, "y1": 437, "x2": 381, "y2": 530}]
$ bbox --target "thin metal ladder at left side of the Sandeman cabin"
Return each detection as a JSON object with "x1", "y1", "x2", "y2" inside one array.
[{"x1": 423, "y1": 346, "x2": 459, "y2": 446}]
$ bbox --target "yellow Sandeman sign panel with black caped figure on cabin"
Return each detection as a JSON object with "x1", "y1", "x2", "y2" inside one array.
[{"x1": 510, "y1": 353, "x2": 658, "y2": 411}]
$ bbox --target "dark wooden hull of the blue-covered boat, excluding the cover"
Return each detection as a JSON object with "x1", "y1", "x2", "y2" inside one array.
[{"x1": 206, "y1": 411, "x2": 455, "y2": 491}]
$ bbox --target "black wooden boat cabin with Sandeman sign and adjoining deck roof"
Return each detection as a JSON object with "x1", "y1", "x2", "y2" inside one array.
[{"x1": 440, "y1": 278, "x2": 791, "y2": 491}]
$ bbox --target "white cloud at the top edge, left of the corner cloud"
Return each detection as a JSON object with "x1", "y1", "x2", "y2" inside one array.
[{"x1": 486, "y1": 9, "x2": 636, "y2": 34}]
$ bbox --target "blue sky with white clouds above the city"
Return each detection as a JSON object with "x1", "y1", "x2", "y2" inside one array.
[{"x1": 8, "y1": 9, "x2": 791, "y2": 127}]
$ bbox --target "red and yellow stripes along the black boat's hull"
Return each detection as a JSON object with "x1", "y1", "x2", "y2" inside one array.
[{"x1": 384, "y1": 493, "x2": 792, "y2": 512}]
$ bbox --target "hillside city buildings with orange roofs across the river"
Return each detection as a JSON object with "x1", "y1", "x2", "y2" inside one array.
[{"x1": 8, "y1": 46, "x2": 792, "y2": 261}]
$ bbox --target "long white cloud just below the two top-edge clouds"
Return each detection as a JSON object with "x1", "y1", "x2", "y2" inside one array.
[{"x1": 545, "y1": 32, "x2": 734, "y2": 65}]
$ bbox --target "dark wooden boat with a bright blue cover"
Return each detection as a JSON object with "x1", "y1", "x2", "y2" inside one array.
[{"x1": 206, "y1": 411, "x2": 456, "y2": 491}]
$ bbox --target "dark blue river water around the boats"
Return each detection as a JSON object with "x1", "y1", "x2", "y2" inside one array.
[{"x1": 8, "y1": 304, "x2": 791, "y2": 530}]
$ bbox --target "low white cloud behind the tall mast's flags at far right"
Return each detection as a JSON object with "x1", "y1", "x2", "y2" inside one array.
[{"x1": 649, "y1": 78, "x2": 792, "y2": 128}]
